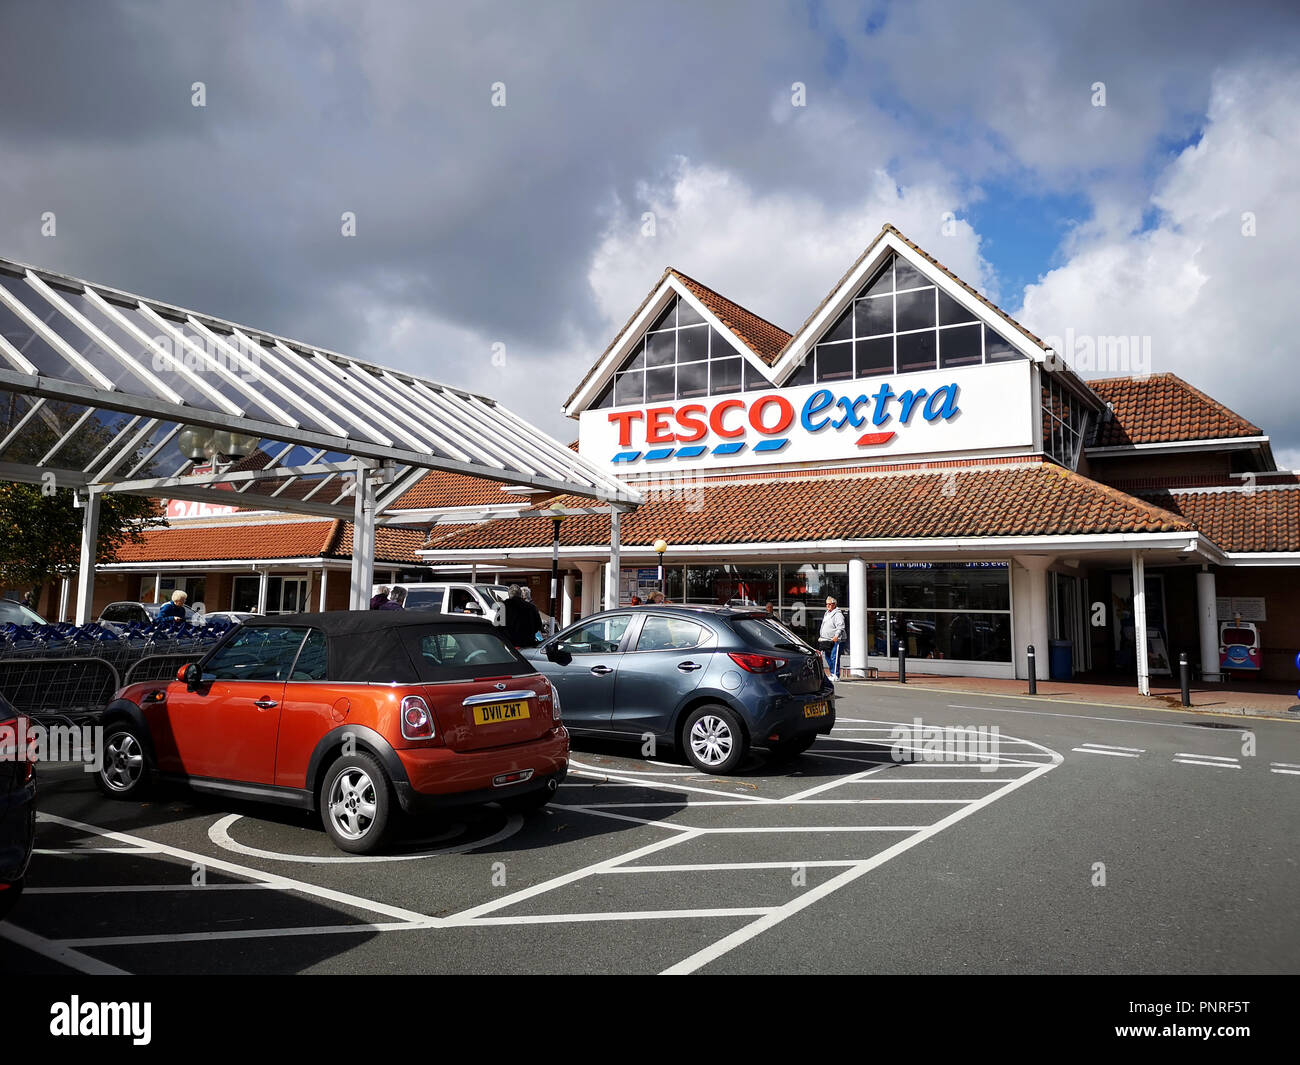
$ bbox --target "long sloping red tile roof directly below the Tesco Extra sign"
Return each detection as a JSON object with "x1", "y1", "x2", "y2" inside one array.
[{"x1": 426, "y1": 462, "x2": 1192, "y2": 553}]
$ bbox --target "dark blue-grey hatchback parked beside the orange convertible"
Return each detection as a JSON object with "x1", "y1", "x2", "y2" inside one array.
[{"x1": 523, "y1": 605, "x2": 835, "y2": 774}]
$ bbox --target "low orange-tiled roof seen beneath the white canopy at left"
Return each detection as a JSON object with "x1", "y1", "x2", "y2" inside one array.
[{"x1": 117, "y1": 520, "x2": 424, "y2": 562}]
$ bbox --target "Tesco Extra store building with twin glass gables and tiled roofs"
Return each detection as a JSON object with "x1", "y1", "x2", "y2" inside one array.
[{"x1": 419, "y1": 226, "x2": 1300, "y2": 690}]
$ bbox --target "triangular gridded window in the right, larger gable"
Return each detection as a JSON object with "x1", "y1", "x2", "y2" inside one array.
[{"x1": 787, "y1": 256, "x2": 1024, "y2": 385}]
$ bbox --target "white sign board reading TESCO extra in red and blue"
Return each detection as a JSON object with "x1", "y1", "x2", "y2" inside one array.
[{"x1": 579, "y1": 362, "x2": 1034, "y2": 472}]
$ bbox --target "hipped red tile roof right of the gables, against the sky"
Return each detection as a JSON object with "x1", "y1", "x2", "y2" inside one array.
[{"x1": 1088, "y1": 373, "x2": 1264, "y2": 447}]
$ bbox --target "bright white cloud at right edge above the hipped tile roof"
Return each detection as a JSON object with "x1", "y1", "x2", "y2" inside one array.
[{"x1": 1019, "y1": 66, "x2": 1300, "y2": 455}]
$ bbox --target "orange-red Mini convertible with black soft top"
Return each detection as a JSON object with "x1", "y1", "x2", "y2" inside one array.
[{"x1": 96, "y1": 610, "x2": 568, "y2": 854}]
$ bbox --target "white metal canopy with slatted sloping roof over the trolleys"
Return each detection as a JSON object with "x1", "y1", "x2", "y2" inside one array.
[{"x1": 0, "y1": 259, "x2": 641, "y2": 622}]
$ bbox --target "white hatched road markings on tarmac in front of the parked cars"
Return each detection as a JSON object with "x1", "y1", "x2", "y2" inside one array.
[{"x1": 0, "y1": 720, "x2": 1063, "y2": 974}]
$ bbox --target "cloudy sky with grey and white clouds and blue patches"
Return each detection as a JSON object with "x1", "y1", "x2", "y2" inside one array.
[{"x1": 0, "y1": 0, "x2": 1300, "y2": 466}]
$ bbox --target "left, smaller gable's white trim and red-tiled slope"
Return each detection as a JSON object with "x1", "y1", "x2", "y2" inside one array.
[{"x1": 564, "y1": 267, "x2": 790, "y2": 417}]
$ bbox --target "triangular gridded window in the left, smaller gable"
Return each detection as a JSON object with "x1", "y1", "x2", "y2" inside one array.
[{"x1": 592, "y1": 296, "x2": 769, "y2": 408}]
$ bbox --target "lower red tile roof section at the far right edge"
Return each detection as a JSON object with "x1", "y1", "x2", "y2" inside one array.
[{"x1": 1144, "y1": 486, "x2": 1300, "y2": 551}]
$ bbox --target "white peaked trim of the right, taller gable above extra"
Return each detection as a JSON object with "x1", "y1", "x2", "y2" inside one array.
[{"x1": 772, "y1": 222, "x2": 1060, "y2": 391}]
